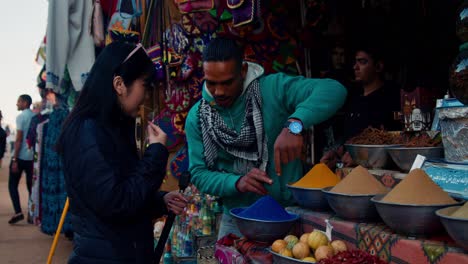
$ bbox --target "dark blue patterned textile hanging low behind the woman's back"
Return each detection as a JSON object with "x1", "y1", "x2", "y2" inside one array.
[{"x1": 40, "y1": 109, "x2": 72, "y2": 235}]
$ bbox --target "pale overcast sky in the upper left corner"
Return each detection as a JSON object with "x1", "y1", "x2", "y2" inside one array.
[{"x1": 0, "y1": 0, "x2": 48, "y2": 127}]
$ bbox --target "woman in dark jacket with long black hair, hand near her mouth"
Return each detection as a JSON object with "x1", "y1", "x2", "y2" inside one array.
[{"x1": 58, "y1": 42, "x2": 187, "y2": 264}]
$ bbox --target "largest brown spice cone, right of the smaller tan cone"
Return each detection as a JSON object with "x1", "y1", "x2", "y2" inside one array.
[{"x1": 382, "y1": 169, "x2": 456, "y2": 205}]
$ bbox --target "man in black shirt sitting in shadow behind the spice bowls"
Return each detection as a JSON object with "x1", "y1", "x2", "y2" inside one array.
[{"x1": 320, "y1": 43, "x2": 401, "y2": 169}]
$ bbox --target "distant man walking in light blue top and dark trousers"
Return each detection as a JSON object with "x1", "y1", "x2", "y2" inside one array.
[{"x1": 8, "y1": 94, "x2": 34, "y2": 224}]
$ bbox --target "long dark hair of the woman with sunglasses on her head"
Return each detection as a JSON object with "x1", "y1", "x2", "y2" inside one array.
[{"x1": 57, "y1": 42, "x2": 155, "y2": 152}]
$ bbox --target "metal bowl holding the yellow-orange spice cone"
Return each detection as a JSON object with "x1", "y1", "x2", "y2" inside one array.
[{"x1": 286, "y1": 184, "x2": 329, "y2": 211}]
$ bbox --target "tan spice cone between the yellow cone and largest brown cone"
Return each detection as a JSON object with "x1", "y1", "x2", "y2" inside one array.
[{"x1": 330, "y1": 166, "x2": 388, "y2": 194}]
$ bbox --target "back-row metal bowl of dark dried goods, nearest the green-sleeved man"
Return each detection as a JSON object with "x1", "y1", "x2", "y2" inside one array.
[{"x1": 345, "y1": 144, "x2": 401, "y2": 169}]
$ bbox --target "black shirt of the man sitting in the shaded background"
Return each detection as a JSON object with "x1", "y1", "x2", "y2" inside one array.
[{"x1": 344, "y1": 84, "x2": 401, "y2": 141}]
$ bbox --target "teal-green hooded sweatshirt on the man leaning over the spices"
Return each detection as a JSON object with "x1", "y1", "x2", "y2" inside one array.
[{"x1": 185, "y1": 63, "x2": 346, "y2": 213}]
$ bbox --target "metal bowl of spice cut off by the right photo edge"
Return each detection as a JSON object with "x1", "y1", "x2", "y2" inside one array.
[{"x1": 436, "y1": 206, "x2": 468, "y2": 250}]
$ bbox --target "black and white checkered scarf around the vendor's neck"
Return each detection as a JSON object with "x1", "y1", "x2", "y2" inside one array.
[{"x1": 198, "y1": 80, "x2": 268, "y2": 175}]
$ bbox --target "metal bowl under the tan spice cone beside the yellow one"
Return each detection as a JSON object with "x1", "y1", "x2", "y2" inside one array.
[{"x1": 323, "y1": 187, "x2": 380, "y2": 222}]
